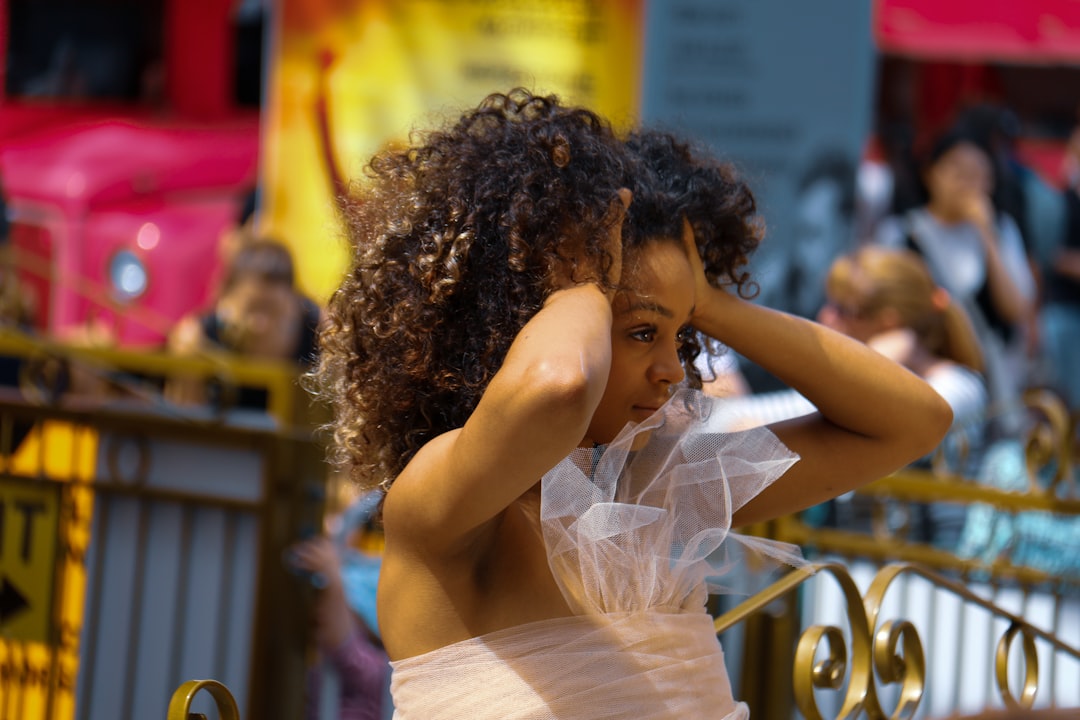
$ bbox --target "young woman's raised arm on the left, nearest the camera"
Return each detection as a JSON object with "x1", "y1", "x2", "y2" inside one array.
[{"x1": 383, "y1": 191, "x2": 630, "y2": 552}]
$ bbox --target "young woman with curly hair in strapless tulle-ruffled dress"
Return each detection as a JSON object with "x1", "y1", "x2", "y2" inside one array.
[{"x1": 321, "y1": 91, "x2": 950, "y2": 719}]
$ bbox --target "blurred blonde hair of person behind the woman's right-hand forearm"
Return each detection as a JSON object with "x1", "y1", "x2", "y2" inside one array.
[{"x1": 826, "y1": 245, "x2": 985, "y2": 372}]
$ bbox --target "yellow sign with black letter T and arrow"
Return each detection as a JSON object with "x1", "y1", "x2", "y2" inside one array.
[{"x1": 0, "y1": 479, "x2": 59, "y2": 642}]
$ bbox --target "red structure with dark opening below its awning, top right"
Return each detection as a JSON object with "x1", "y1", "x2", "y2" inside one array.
[{"x1": 874, "y1": 0, "x2": 1080, "y2": 185}]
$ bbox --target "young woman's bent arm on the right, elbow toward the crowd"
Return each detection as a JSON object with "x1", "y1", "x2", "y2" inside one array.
[{"x1": 684, "y1": 223, "x2": 951, "y2": 525}]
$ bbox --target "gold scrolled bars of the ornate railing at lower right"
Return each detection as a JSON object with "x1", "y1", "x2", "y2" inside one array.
[{"x1": 717, "y1": 391, "x2": 1080, "y2": 718}]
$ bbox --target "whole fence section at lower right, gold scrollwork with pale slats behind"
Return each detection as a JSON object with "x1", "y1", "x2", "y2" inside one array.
[{"x1": 730, "y1": 392, "x2": 1080, "y2": 720}]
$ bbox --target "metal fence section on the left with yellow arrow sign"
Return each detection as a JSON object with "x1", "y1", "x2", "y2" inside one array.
[{"x1": 0, "y1": 328, "x2": 326, "y2": 720}]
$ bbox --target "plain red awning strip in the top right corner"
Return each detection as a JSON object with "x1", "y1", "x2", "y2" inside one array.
[{"x1": 874, "y1": 0, "x2": 1080, "y2": 64}]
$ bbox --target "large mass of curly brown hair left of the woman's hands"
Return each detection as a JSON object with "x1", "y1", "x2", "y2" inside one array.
[{"x1": 313, "y1": 89, "x2": 634, "y2": 487}]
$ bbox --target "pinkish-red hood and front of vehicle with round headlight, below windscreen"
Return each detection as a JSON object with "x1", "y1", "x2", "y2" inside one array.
[{"x1": 0, "y1": 113, "x2": 258, "y2": 347}]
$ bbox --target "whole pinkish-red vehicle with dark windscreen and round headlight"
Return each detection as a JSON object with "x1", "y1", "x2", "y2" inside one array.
[{"x1": 0, "y1": 0, "x2": 261, "y2": 348}]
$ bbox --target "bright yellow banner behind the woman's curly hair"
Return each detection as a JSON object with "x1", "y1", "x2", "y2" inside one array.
[{"x1": 260, "y1": 0, "x2": 644, "y2": 301}]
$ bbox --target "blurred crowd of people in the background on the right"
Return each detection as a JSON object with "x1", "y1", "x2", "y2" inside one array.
[{"x1": 700, "y1": 101, "x2": 1080, "y2": 575}]
